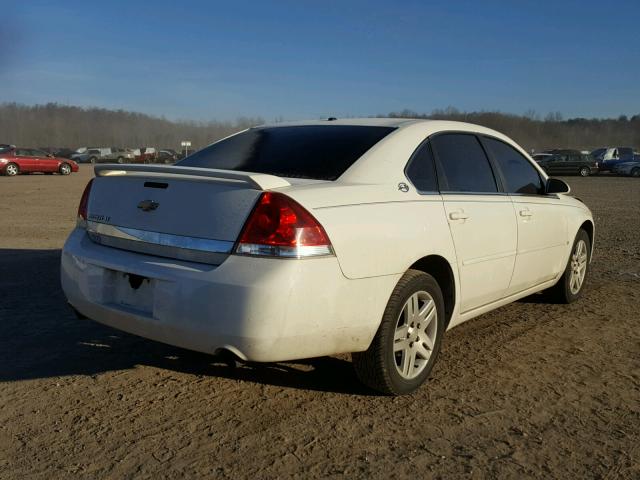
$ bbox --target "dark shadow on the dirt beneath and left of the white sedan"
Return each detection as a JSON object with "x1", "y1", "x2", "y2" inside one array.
[{"x1": 0, "y1": 249, "x2": 375, "y2": 395}]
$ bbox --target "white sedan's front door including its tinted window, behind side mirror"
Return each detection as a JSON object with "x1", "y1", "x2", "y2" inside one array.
[{"x1": 482, "y1": 136, "x2": 569, "y2": 295}]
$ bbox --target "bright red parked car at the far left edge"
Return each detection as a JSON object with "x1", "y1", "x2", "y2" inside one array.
[{"x1": 0, "y1": 147, "x2": 78, "y2": 177}]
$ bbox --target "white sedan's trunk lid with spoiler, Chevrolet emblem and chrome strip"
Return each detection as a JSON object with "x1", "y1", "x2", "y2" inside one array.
[{"x1": 87, "y1": 165, "x2": 290, "y2": 264}]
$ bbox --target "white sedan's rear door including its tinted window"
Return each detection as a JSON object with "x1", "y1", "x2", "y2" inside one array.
[{"x1": 431, "y1": 132, "x2": 517, "y2": 313}]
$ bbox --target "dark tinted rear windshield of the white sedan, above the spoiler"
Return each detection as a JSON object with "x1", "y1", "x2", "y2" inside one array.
[{"x1": 177, "y1": 125, "x2": 394, "y2": 180}]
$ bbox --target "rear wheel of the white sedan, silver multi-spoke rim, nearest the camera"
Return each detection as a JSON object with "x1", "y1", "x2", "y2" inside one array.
[{"x1": 351, "y1": 270, "x2": 445, "y2": 395}]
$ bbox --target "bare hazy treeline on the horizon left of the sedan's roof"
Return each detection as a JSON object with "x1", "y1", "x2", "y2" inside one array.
[{"x1": 0, "y1": 103, "x2": 263, "y2": 150}]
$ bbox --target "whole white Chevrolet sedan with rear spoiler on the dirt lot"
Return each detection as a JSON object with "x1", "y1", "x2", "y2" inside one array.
[{"x1": 61, "y1": 119, "x2": 594, "y2": 394}]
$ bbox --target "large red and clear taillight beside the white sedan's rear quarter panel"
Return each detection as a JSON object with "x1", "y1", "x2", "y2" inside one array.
[{"x1": 236, "y1": 192, "x2": 333, "y2": 258}]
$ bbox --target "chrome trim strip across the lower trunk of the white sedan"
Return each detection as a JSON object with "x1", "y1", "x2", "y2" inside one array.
[{"x1": 87, "y1": 221, "x2": 234, "y2": 265}]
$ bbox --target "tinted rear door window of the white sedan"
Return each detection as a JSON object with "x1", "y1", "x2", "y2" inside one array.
[{"x1": 431, "y1": 133, "x2": 498, "y2": 193}]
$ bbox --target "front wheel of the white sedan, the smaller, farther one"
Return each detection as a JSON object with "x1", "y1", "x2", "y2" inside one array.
[{"x1": 548, "y1": 229, "x2": 591, "y2": 303}]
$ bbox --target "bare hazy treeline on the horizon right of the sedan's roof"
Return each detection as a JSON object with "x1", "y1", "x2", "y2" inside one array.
[{"x1": 389, "y1": 107, "x2": 640, "y2": 151}]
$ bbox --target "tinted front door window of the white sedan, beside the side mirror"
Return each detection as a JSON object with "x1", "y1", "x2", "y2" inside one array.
[{"x1": 483, "y1": 137, "x2": 544, "y2": 195}]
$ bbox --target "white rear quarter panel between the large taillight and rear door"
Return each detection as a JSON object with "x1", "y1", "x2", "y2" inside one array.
[{"x1": 288, "y1": 185, "x2": 457, "y2": 279}]
